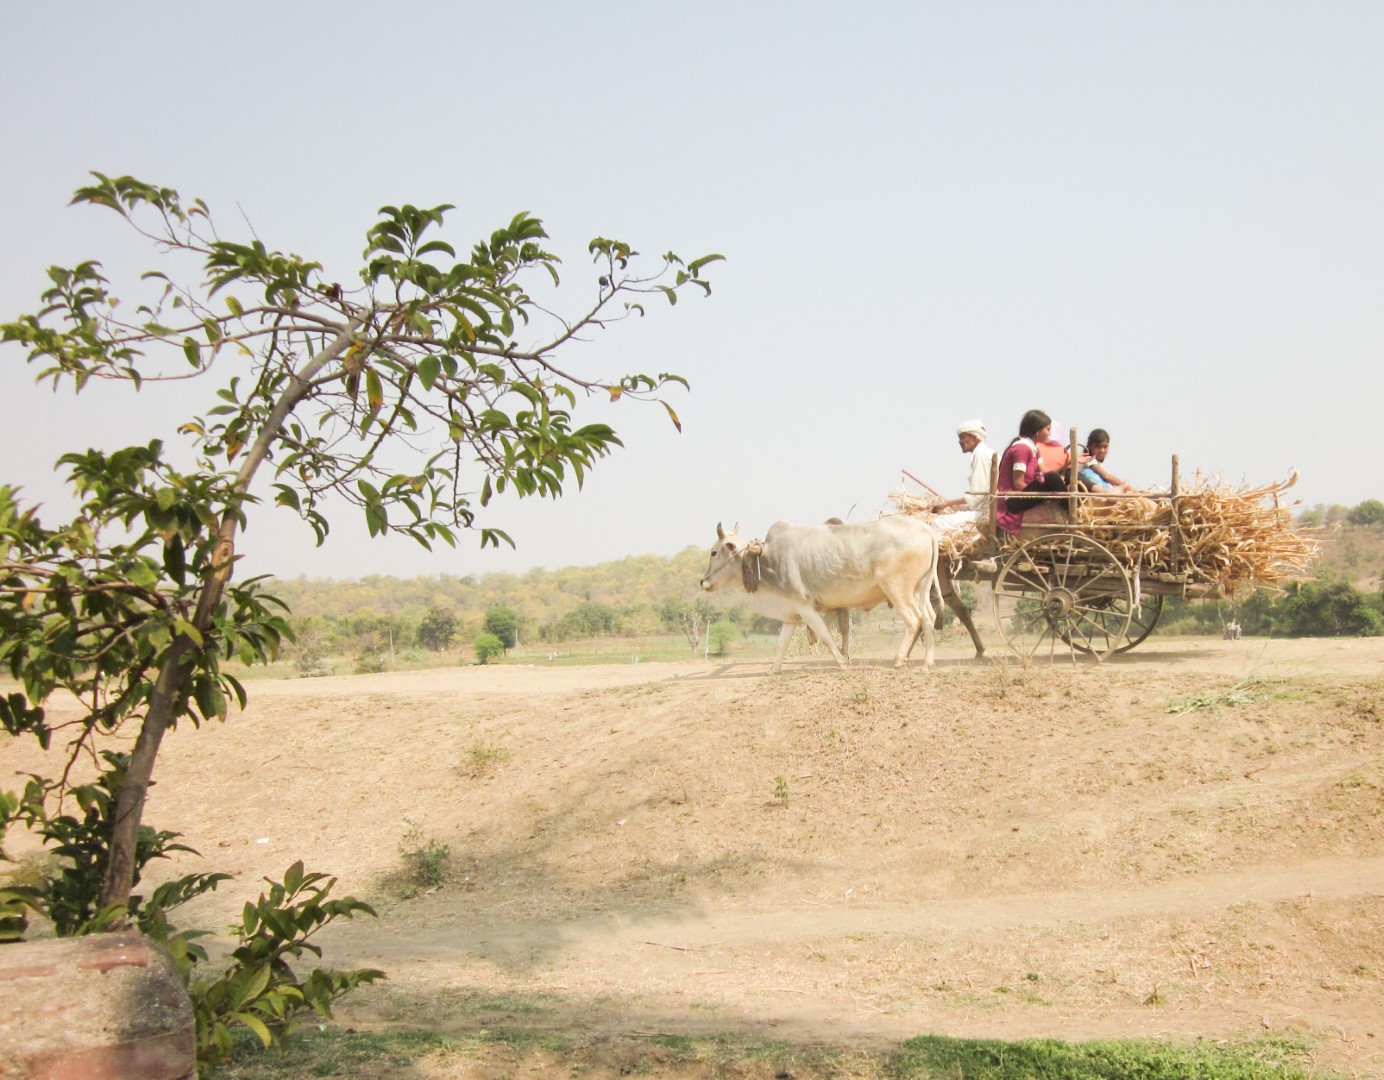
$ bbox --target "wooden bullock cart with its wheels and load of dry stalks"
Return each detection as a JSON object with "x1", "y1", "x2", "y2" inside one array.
[{"x1": 894, "y1": 432, "x2": 1316, "y2": 663}]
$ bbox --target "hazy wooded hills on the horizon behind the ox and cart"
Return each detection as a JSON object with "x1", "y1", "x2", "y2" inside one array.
[{"x1": 270, "y1": 500, "x2": 1384, "y2": 655}]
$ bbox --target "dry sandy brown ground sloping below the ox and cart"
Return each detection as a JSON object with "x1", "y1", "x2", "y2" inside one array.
[{"x1": 0, "y1": 638, "x2": 1384, "y2": 1076}]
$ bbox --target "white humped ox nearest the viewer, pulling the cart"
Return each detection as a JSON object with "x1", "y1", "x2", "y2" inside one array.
[{"x1": 702, "y1": 515, "x2": 937, "y2": 673}]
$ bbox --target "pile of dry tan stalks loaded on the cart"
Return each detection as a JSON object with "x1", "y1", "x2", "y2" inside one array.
[{"x1": 890, "y1": 472, "x2": 1318, "y2": 597}]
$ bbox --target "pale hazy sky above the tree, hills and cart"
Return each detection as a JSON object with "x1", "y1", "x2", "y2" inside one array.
[{"x1": 0, "y1": 0, "x2": 1384, "y2": 577}]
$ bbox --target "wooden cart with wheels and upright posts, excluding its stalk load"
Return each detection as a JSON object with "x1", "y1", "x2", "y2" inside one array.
[{"x1": 952, "y1": 428, "x2": 1223, "y2": 663}]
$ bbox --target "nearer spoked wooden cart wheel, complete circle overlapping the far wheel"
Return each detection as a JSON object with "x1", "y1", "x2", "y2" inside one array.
[{"x1": 995, "y1": 533, "x2": 1134, "y2": 663}]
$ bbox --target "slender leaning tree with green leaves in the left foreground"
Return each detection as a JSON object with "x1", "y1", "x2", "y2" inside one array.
[{"x1": 0, "y1": 173, "x2": 720, "y2": 925}]
